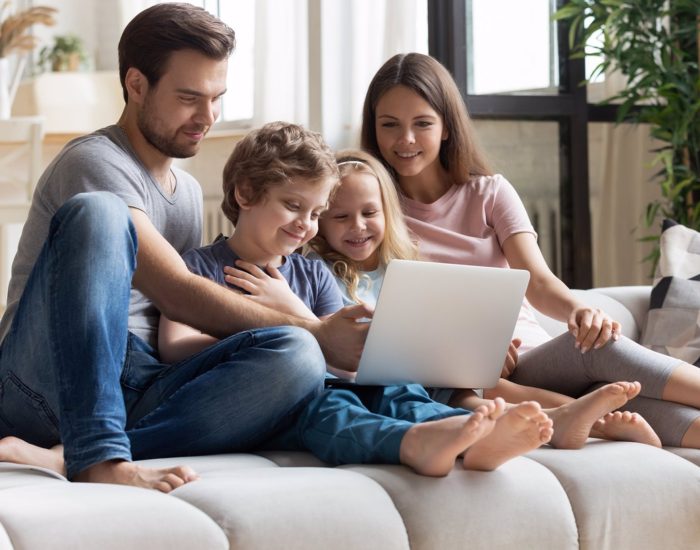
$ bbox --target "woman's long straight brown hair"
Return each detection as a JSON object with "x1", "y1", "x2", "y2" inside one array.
[{"x1": 361, "y1": 53, "x2": 492, "y2": 185}]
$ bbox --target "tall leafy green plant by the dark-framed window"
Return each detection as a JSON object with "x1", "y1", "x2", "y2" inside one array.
[{"x1": 554, "y1": 0, "x2": 700, "y2": 265}]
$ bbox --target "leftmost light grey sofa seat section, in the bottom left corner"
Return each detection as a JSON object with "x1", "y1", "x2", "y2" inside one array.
[{"x1": 0, "y1": 468, "x2": 228, "y2": 550}]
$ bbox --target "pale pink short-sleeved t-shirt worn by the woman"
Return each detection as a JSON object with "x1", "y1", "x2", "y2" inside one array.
[{"x1": 401, "y1": 174, "x2": 550, "y2": 352}]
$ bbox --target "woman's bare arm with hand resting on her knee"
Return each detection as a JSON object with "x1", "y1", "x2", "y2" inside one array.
[{"x1": 502, "y1": 233, "x2": 620, "y2": 352}]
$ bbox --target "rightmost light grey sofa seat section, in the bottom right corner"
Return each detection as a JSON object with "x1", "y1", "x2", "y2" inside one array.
[{"x1": 527, "y1": 440, "x2": 700, "y2": 548}]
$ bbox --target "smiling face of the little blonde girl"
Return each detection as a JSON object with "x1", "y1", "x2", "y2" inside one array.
[{"x1": 320, "y1": 172, "x2": 385, "y2": 271}]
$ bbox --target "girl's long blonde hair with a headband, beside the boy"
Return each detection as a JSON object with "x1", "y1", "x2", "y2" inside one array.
[{"x1": 309, "y1": 149, "x2": 418, "y2": 302}]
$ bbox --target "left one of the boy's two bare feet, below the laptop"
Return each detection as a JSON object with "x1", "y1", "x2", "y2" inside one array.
[{"x1": 399, "y1": 398, "x2": 505, "y2": 477}]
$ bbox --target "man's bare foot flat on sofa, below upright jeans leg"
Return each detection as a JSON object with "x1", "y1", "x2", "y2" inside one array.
[{"x1": 73, "y1": 460, "x2": 198, "y2": 493}]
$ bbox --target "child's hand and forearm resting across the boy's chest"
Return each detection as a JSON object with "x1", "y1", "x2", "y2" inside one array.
[{"x1": 224, "y1": 260, "x2": 316, "y2": 319}]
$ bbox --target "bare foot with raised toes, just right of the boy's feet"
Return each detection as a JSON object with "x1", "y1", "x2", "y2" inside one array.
[{"x1": 547, "y1": 382, "x2": 641, "y2": 449}]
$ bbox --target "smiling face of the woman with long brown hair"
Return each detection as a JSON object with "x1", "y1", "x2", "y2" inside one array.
[{"x1": 375, "y1": 85, "x2": 447, "y2": 178}]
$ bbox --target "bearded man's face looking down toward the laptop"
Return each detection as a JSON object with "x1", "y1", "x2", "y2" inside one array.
[{"x1": 137, "y1": 50, "x2": 228, "y2": 158}]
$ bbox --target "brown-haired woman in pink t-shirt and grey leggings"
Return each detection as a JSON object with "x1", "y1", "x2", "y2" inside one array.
[{"x1": 362, "y1": 49, "x2": 700, "y2": 448}]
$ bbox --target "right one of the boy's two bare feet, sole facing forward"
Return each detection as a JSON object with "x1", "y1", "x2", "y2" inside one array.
[{"x1": 463, "y1": 401, "x2": 552, "y2": 471}]
